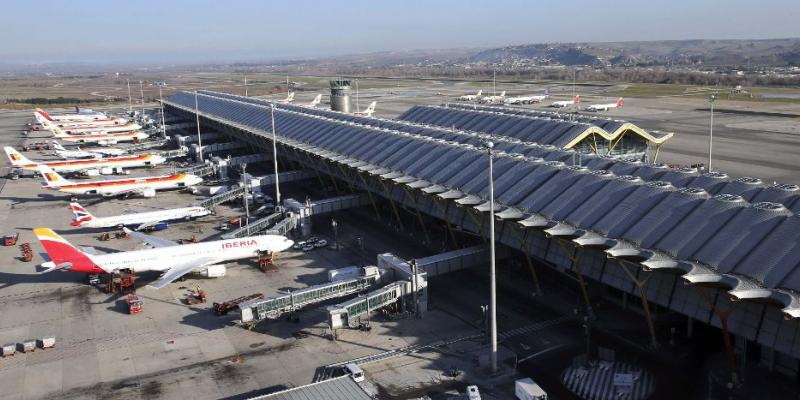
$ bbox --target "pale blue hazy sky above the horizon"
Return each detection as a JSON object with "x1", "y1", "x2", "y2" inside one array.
[{"x1": 0, "y1": 0, "x2": 800, "y2": 64}]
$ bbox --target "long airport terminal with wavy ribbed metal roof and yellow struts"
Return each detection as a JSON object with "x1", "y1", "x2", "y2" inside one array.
[{"x1": 164, "y1": 91, "x2": 800, "y2": 382}]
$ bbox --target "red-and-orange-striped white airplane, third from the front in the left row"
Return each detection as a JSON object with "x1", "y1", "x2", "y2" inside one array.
[{"x1": 39, "y1": 165, "x2": 203, "y2": 197}]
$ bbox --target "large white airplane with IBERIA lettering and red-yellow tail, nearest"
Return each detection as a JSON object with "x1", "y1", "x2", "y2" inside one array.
[{"x1": 33, "y1": 228, "x2": 293, "y2": 289}]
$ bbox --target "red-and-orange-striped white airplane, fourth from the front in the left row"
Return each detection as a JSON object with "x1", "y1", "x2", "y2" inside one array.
[{"x1": 3, "y1": 146, "x2": 167, "y2": 172}]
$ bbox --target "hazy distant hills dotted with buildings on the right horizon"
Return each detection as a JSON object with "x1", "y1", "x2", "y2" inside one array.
[{"x1": 465, "y1": 38, "x2": 800, "y2": 66}]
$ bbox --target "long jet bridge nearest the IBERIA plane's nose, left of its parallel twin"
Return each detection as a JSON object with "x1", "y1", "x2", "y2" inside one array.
[{"x1": 239, "y1": 267, "x2": 381, "y2": 323}]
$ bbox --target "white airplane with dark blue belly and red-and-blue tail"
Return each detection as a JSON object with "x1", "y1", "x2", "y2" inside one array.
[{"x1": 69, "y1": 202, "x2": 211, "y2": 231}]
